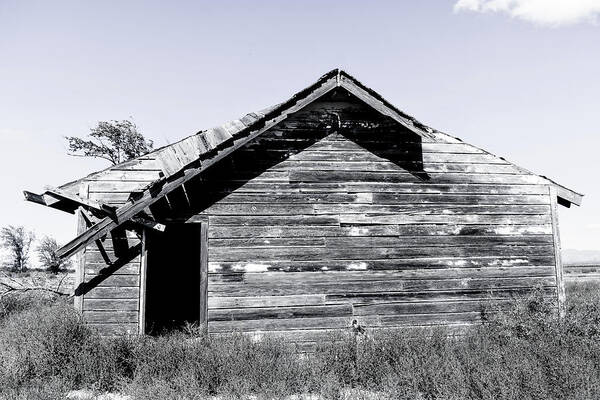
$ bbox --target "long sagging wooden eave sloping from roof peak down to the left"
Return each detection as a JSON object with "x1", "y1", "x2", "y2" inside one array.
[{"x1": 56, "y1": 77, "x2": 336, "y2": 258}]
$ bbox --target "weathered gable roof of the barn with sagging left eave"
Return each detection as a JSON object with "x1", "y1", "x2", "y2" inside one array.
[{"x1": 25, "y1": 69, "x2": 582, "y2": 257}]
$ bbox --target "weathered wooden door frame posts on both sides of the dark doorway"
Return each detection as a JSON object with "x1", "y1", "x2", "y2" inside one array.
[{"x1": 138, "y1": 220, "x2": 208, "y2": 335}]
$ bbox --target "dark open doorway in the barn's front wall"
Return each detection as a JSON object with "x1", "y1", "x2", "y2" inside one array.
[{"x1": 145, "y1": 224, "x2": 206, "y2": 334}]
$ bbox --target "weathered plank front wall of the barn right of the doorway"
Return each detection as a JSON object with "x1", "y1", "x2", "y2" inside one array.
[{"x1": 188, "y1": 94, "x2": 556, "y2": 342}]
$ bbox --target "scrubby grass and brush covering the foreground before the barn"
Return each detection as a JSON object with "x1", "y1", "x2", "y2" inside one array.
[{"x1": 0, "y1": 283, "x2": 600, "y2": 400}]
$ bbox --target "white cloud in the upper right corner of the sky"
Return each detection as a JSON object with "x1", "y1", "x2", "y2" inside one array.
[{"x1": 454, "y1": 0, "x2": 600, "y2": 26}]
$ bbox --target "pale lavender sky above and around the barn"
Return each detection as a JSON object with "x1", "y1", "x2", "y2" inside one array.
[{"x1": 0, "y1": 0, "x2": 600, "y2": 255}]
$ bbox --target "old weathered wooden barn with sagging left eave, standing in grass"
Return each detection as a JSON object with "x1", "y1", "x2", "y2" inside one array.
[{"x1": 25, "y1": 70, "x2": 582, "y2": 343}]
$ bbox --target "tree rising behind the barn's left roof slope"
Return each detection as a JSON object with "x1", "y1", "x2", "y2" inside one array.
[{"x1": 65, "y1": 120, "x2": 153, "y2": 165}]
